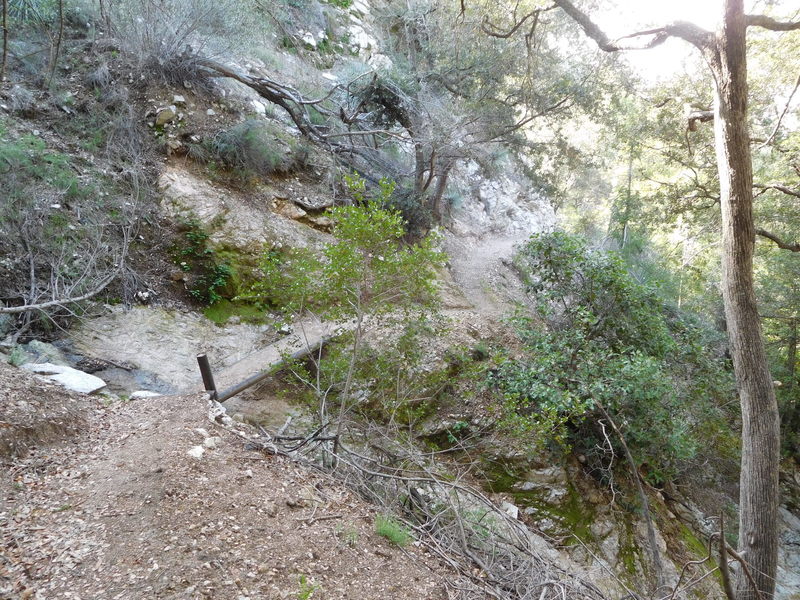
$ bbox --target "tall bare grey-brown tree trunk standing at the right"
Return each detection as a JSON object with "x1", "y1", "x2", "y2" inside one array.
[{"x1": 707, "y1": 0, "x2": 780, "y2": 600}]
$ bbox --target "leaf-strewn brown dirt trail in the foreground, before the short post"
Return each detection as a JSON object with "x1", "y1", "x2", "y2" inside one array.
[{"x1": 0, "y1": 386, "x2": 445, "y2": 600}]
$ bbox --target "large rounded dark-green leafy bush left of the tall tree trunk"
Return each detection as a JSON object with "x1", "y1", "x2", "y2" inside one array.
[{"x1": 494, "y1": 233, "x2": 731, "y2": 483}]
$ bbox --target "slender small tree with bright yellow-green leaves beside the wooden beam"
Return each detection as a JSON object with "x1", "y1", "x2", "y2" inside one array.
[{"x1": 245, "y1": 177, "x2": 444, "y2": 462}]
